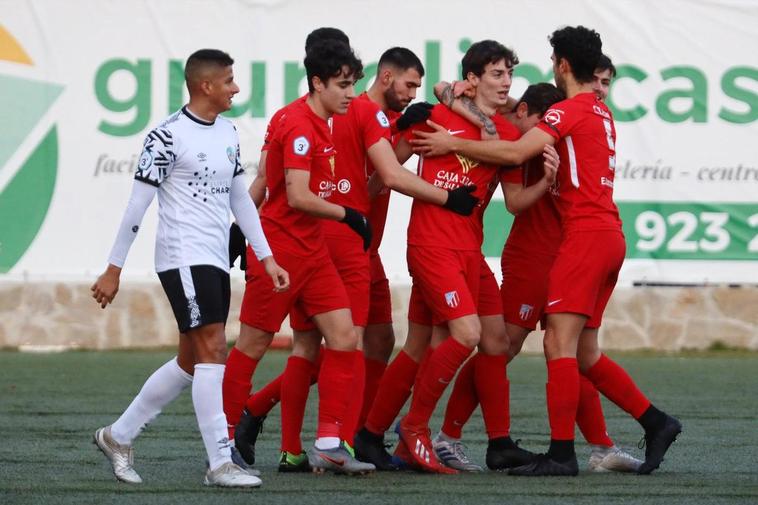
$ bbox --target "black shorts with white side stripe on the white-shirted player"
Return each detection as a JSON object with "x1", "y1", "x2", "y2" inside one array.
[{"x1": 158, "y1": 265, "x2": 231, "y2": 333}]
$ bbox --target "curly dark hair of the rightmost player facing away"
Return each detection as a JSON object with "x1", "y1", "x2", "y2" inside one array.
[{"x1": 550, "y1": 26, "x2": 603, "y2": 83}]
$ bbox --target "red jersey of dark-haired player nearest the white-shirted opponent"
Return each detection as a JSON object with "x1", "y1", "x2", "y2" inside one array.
[{"x1": 261, "y1": 100, "x2": 336, "y2": 256}]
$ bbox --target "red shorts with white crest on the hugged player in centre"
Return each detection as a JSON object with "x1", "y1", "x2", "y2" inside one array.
[{"x1": 407, "y1": 245, "x2": 482, "y2": 325}]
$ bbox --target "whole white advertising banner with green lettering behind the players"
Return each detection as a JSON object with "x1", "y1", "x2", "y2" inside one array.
[{"x1": 0, "y1": 0, "x2": 758, "y2": 285}]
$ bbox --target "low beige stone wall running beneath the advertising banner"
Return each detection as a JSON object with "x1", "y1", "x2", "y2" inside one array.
[{"x1": 0, "y1": 281, "x2": 758, "y2": 352}]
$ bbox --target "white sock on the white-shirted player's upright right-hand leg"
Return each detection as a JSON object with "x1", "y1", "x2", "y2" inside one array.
[{"x1": 192, "y1": 363, "x2": 232, "y2": 471}]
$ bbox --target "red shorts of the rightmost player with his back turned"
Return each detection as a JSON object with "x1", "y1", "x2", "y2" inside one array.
[{"x1": 545, "y1": 230, "x2": 626, "y2": 328}]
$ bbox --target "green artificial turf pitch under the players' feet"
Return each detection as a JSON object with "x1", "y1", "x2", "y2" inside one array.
[{"x1": 0, "y1": 351, "x2": 758, "y2": 505}]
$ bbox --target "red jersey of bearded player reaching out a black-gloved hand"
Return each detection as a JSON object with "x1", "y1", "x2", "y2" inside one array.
[{"x1": 323, "y1": 93, "x2": 390, "y2": 236}]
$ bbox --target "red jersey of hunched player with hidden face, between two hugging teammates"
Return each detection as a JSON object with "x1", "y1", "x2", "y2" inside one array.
[{"x1": 500, "y1": 156, "x2": 561, "y2": 258}]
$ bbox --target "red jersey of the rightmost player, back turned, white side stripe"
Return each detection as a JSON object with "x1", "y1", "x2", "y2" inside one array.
[{"x1": 537, "y1": 93, "x2": 621, "y2": 231}]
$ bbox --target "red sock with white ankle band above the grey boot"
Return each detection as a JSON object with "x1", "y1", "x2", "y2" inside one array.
[{"x1": 316, "y1": 348, "x2": 355, "y2": 438}]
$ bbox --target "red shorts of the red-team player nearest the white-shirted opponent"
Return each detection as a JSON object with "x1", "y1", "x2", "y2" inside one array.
[{"x1": 240, "y1": 247, "x2": 350, "y2": 333}]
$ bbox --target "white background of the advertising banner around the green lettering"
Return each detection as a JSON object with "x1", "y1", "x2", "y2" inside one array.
[{"x1": 0, "y1": 0, "x2": 758, "y2": 284}]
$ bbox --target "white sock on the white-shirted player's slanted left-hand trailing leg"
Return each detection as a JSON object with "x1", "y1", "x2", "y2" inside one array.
[{"x1": 111, "y1": 358, "x2": 192, "y2": 445}]
